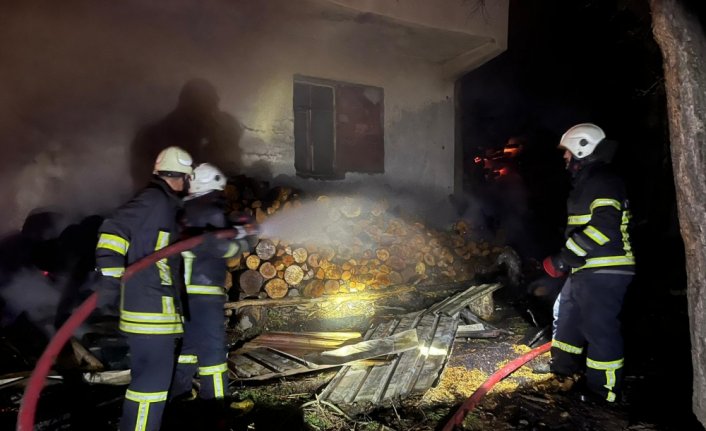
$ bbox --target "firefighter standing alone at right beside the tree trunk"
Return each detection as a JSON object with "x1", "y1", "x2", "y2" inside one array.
[{"x1": 543, "y1": 123, "x2": 635, "y2": 402}]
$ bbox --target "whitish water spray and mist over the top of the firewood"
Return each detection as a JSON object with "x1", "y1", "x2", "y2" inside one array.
[{"x1": 260, "y1": 177, "x2": 494, "y2": 253}]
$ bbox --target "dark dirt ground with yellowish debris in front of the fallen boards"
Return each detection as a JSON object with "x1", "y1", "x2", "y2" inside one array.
[{"x1": 208, "y1": 290, "x2": 702, "y2": 431}]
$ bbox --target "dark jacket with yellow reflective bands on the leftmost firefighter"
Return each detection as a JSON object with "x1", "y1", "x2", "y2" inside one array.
[{"x1": 96, "y1": 177, "x2": 183, "y2": 336}]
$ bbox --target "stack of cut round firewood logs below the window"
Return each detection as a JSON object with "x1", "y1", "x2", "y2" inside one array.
[{"x1": 220, "y1": 177, "x2": 501, "y2": 299}]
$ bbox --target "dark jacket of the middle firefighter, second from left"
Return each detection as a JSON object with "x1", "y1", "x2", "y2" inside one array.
[{"x1": 182, "y1": 191, "x2": 241, "y2": 300}]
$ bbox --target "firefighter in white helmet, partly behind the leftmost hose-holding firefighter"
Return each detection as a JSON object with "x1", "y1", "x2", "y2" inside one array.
[{"x1": 172, "y1": 163, "x2": 249, "y2": 400}]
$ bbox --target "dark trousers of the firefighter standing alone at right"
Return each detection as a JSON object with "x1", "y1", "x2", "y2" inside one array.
[{"x1": 551, "y1": 272, "x2": 633, "y2": 402}]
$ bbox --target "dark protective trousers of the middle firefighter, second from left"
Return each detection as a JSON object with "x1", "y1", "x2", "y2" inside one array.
[{"x1": 172, "y1": 294, "x2": 228, "y2": 400}]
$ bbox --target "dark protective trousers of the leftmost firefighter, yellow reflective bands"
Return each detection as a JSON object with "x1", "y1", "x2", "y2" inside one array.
[{"x1": 120, "y1": 334, "x2": 177, "y2": 431}]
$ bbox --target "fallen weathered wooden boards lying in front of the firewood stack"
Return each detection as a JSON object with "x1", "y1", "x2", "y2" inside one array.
[{"x1": 229, "y1": 283, "x2": 501, "y2": 404}]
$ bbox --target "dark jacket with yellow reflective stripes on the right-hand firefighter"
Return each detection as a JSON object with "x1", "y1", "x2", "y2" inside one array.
[{"x1": 560, "y1": 163, "x2": 635, "y2": 274}]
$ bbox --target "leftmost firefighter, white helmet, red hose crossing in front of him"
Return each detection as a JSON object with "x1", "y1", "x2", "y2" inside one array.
[{"x1": 96, "y1": 147, "x2": 192, "y2": 431}]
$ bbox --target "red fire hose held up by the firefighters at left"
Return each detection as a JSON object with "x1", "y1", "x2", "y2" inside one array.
[{"x1": 17, "y1": 229, "x2": 237, "y2": 431}]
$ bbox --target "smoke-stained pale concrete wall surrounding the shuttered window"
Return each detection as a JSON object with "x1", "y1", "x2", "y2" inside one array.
[{"x1": 0, "y1": 0, "x2": 506, "y2": 232}]
